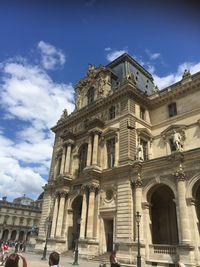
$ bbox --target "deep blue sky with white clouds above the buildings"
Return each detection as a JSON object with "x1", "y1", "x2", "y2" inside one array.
[{"x1": 0, "y1": 0, "x2": 200, "y2": 200}]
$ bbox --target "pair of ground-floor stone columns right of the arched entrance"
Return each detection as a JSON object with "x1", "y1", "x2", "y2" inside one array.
[{"x1": 80, "y1": 185, "x2": 98, "y2": 239}]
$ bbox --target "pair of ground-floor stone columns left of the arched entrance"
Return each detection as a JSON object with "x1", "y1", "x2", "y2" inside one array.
[{"x1": 50, "y1": 192, "x2": 67, "y2": 238}]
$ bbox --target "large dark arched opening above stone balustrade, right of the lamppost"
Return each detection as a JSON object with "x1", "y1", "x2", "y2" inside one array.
[{"x1": 149, "y1": 185, "x2": 178, "y2": 245}]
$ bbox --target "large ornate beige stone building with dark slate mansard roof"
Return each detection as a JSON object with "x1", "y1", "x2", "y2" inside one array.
[{"x1": 37, "y1": 54, "x2": 200, "y2": 266}]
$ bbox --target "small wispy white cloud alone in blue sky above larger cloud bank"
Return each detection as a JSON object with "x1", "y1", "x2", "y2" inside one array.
[{"x1": 38, "y1": 41, "x2": 65, "y2": 70}]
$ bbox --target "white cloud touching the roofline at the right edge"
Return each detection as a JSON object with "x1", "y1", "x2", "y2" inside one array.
[{"x1": 153, "y1": 62, "x2": 200, "y2": 89}]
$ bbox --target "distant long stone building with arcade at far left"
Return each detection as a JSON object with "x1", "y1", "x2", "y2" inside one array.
[{"x1": 0, "y1": 194, "x2": 42, "y2": 241}]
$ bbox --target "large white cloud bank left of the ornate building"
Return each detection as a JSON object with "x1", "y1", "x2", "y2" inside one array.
[{"x1": 0, "y1": 42, "x2": 74, "y2": 201}]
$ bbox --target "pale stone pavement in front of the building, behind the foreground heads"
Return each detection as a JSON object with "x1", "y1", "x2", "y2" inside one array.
[{"x1": 20, "y1": 252, "x2": 100, "y2": 267}]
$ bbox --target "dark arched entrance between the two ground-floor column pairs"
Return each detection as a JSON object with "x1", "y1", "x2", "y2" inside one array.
[{"x1": 68, "y1": 196, "x2": 83, "y2": 249}]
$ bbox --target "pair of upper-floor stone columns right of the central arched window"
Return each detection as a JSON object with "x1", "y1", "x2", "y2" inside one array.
[{"x1": 87, "y1": 131, "x2": 100, "y2": 166}]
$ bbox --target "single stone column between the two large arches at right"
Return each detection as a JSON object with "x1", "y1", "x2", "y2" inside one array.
[{"x1": 175, "y1": 164, "x2": 190, "y2": 244}]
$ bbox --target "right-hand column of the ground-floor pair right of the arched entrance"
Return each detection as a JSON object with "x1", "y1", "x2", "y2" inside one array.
[{"x1": 87, "y1": 185, "x2": 96, "y2": 239}]
